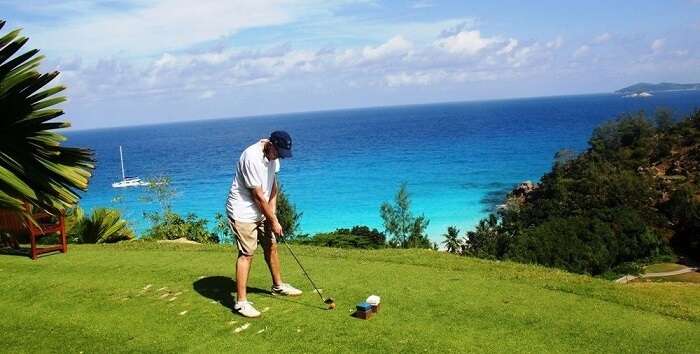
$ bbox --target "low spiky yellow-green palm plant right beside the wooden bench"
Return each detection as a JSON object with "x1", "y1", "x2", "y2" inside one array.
[{"x1": 66, "y1": 207, "x2": 135, "y2": 243}]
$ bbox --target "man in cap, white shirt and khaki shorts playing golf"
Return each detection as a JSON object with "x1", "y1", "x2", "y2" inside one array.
[{"x1": 226, "y1": 131, "x2": 301, "y2": 317}]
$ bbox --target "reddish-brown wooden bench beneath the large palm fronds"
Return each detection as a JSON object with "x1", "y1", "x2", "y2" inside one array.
[{"x1": 0, "y1": 206, "x2": 68, "y2": 259}]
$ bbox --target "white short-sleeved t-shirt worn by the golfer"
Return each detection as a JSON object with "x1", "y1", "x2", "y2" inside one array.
[{"x1": 226, "y1": 140, "x2": 280, "y2": 222}]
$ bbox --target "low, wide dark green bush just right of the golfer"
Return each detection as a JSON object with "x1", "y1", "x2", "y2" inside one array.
[{"x1": 295, "y1": 226, "x2": 386, "y2": 249}]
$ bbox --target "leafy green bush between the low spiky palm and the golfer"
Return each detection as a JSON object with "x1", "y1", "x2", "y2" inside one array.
[{"x1": 143, "y1": 211, "x2": 220, "y2": 243}]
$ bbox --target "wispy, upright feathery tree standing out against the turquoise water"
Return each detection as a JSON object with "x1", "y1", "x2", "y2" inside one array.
[{"x1": 379, "y1": 183, "x2": 435, "y2": 248}]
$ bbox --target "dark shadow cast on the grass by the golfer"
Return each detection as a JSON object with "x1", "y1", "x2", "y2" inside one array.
[{"x1": 192, "y1": 275, "x2": 324, "y2": 312}]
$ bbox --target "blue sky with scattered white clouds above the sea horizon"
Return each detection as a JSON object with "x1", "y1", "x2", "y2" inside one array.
[{"x1": 0, "y1": 0, "x2": 700, "y2": 129}]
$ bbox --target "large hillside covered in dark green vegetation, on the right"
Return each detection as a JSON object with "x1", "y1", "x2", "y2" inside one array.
[{"x1": 460, "y1": 110, "x2": 700, "y2": 275}]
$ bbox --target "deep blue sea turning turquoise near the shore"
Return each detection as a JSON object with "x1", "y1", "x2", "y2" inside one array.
[{"x1": 67, "y1": 91, "x2": 700, "y2": 240}]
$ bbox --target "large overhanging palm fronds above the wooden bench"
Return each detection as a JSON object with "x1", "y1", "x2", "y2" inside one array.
[{"x1": 0, "y1": 20, "x2": 94, "y2": 220}]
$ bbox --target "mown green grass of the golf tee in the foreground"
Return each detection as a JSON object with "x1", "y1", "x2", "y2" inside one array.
[{"x1": 0, "y1": 242, "x2": 700, "y2": 353}]
